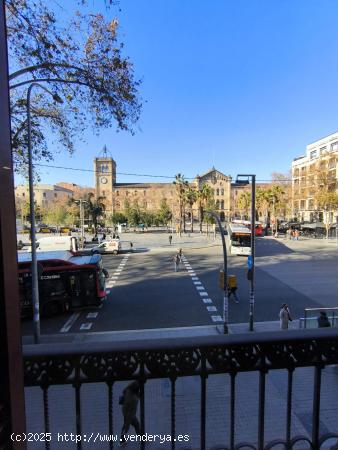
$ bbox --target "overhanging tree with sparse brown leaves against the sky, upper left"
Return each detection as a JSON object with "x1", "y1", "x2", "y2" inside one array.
[{"x1": 5, "y1": 0, "x2": 141, "y2": 170}]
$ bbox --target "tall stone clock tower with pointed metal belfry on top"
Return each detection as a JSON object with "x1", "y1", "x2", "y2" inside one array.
[{"x1": 94, "y1": 146, "x2": 116, "y2": 212}]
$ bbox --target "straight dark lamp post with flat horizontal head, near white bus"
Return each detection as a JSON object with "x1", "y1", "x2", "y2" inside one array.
[{"x1": 236, "y1": 174, "x2": 256, "y2": 331}]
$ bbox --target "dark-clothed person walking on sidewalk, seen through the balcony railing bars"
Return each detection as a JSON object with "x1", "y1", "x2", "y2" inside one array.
[{"x1": 119, "y1": 381, "x2": 141, "y2": 447}]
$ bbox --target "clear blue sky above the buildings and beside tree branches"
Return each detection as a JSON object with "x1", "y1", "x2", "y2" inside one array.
[{"x1": 16, "y1": 0, "x2": 338, "y2": 185}]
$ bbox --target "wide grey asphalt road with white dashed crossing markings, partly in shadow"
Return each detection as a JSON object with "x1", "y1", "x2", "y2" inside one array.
[{"x1": 22, "y1": 238, "x2": 338, "y2": 334}]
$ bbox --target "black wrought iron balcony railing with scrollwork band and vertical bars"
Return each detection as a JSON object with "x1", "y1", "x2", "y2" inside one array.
[{"x1": 24, "y1": 329, "x2": 338, "y2": 450}]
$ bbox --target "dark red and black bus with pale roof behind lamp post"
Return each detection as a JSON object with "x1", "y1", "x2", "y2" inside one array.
[{"x1": 18, "y1": 251, "x2": 108, "y2": 317}]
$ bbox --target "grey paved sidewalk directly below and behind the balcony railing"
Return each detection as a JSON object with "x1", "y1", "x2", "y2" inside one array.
[{"x1": 26, "y1": 322, "x2": 338, "y2": 450}]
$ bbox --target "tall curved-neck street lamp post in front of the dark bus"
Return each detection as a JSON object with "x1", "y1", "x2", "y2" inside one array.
[{"x1": 26, "y1": 83, "x2": 63, "y2": 344}]
